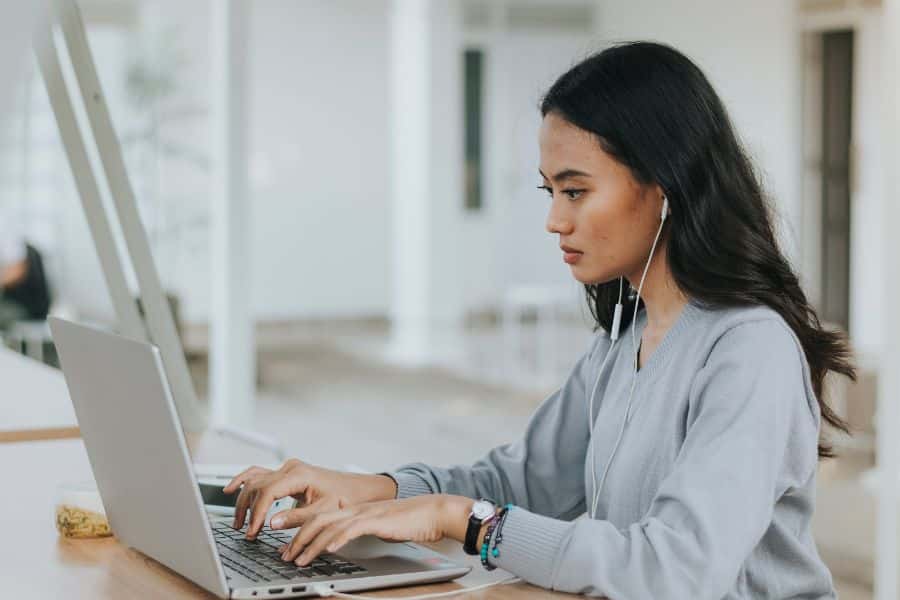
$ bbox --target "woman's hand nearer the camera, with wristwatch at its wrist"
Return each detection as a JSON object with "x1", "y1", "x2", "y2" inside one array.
[{"x1": 281, "y1": 494, "x2": 473, "y2": 566}]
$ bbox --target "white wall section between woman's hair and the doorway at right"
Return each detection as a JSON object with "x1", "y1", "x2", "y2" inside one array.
[{"x1": 600, "y1": 0, "x2": 801, "y2": 259}]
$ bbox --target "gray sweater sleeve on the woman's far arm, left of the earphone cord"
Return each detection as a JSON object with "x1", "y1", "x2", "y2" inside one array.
[{"x1": 388, "y1": 335, "x2": 609, "y2": 519}]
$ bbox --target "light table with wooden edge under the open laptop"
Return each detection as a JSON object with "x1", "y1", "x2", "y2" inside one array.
[{"x1": 0, "y1": 440, "x2": 573, "y2": 600}]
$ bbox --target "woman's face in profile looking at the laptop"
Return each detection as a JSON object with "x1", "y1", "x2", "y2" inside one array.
[{"x1": 540, "y1": 112, "x2": 664, "y2": 287}]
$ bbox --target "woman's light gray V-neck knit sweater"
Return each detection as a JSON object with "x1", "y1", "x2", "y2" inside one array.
[{"x1": 391, "y1": 300, "x2": 835, "y2": 600}]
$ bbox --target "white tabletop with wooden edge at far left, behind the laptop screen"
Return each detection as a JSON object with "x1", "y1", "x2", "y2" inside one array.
[{"x1": 0, "y1": 346, "x2": 80, "y2": 443}]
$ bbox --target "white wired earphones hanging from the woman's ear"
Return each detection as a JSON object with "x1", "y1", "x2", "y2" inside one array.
[{"x1": 588, "y1": 196, "x2": 669, "y2": 519}]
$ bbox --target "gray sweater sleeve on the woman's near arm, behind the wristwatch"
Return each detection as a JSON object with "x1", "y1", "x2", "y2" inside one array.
[{"x1": 478, "y1": 320, "x2": 819, "y2": 599}]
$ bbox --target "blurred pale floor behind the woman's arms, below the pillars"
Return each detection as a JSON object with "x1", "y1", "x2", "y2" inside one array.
[{"x1": 193, "y1": 327, "x2": 872, "y2": 600}]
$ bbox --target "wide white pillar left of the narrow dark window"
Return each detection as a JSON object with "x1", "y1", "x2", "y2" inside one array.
[{"x1": 388, "y1": 0, "x2": 463, "y2": 364}]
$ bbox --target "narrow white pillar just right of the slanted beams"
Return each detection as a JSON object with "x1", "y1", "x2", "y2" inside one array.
[{"x1": 209, "y1": 0, "x2": 256, "y2": 426}]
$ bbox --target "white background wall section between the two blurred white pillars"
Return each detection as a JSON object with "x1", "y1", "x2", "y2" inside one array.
[{"x1": 248, "y1": 0, "x2": 389, "y2": 319}]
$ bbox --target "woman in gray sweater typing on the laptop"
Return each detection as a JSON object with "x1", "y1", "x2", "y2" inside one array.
[{"x1": 226, "y1": 43, "x2": 855, "y2": 598}]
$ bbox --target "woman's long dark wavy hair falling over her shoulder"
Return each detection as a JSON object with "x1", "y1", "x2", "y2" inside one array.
[{"x1": 540, "y1": 42, "x2": 856, "y2": 458}]
